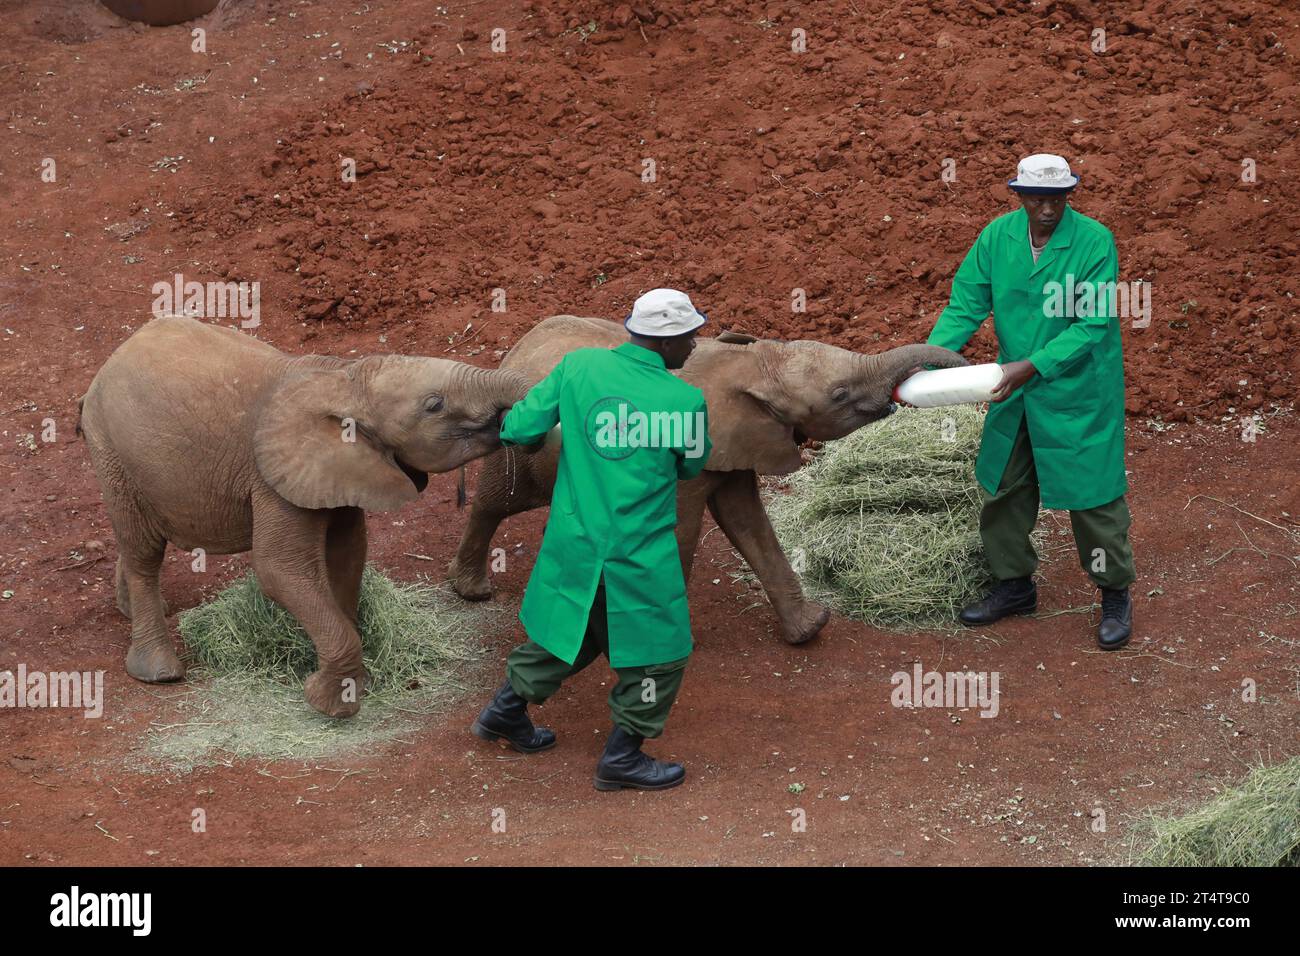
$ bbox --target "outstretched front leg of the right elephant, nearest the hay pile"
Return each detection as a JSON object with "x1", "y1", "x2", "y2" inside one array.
[{"x1": 709, "y1": 471, "x2": 831, "y2": 644}]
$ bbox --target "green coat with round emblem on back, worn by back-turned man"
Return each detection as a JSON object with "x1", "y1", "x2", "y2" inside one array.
[{"x1": 501, "y1": 342, "x2": 712, "y2": 667}]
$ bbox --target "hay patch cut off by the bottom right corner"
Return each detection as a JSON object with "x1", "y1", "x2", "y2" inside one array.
[{"x1": 1130, "y1": 757, "x2": 1300, "y2": 866}]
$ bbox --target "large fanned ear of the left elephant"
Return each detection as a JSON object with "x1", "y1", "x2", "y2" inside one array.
[{"x1": 254, "y1": 362, "x2": 428, "y2": 511}]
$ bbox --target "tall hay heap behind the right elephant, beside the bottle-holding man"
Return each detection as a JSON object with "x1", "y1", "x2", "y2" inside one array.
[{"x1": 767, "y1": 405, "x2": 1019, "y2": 630}]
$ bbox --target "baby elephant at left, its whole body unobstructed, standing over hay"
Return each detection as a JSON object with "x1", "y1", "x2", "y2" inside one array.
[{"x1": 77, "y1": 317, "x2": 529, "y2": 717}]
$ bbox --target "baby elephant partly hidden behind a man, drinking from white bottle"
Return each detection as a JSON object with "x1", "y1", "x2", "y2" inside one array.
[{"x1": 449, "y1": 316, "x2": 967, "y2": 644}]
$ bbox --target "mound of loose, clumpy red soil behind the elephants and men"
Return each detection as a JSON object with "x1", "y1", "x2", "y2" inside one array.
[{"x1": 181, "y1": 0, "x2": 1300, "y2": 420}]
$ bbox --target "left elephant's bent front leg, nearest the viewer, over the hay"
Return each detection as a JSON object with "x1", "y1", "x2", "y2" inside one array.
[{"x1": 252, "y1": 489, "x2": 368, "y2": 717}]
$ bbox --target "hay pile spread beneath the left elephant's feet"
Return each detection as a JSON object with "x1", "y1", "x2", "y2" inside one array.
[{"x1": 144, "y1": 567, "x2": 506, "y2": 770}]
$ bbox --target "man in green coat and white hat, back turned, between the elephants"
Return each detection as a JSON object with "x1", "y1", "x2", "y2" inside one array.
[{"x1": 472, "y1": 289, "x2": 711, "y2": 790}]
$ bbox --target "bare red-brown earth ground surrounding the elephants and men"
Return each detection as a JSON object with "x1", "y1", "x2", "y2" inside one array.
[{"x1": 0, "y1": 0, "x2": 1300, "y2": 865}]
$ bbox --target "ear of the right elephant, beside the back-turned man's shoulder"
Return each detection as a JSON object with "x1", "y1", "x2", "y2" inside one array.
[{"x1": 683, "y1": 341, "x2": 803, "y2": 475}]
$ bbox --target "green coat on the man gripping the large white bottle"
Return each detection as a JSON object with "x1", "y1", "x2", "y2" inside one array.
[{"x1": 928, "y1": 206, "x2": 1127, "y2": 511}]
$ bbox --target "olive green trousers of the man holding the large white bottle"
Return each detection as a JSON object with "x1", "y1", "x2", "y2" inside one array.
[{"x1": 979, "y1": 420, "x2": 1136, "y2": 589}]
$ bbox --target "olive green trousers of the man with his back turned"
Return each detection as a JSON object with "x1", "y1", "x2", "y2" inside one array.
[{"x1": 506, "y1": 581, "x2": 690, "y2": 737}]
